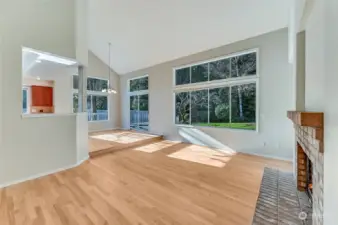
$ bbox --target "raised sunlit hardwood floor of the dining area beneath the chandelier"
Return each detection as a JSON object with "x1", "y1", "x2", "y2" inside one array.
[{"x1": 89, "y1": 130, "x2": 162, "y2": 157}]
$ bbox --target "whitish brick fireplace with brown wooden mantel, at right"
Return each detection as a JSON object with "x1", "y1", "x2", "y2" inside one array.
[{"x1": 288, "y1": 111, "x2": 324, "y2": 225}]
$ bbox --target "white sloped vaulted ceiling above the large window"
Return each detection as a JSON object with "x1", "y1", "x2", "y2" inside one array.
[{"x1": 89, "y1": 0, "x2": 290, "y2": 74}]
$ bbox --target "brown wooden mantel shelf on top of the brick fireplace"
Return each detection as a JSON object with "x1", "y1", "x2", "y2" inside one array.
[{"x1": 288, "y1": 111, "x2": 324, "y2": 128}]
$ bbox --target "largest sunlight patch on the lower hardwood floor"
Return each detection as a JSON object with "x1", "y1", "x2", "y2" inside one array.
[{"x1": 168, "y1": 145, "x2": 234, "y2": 168}]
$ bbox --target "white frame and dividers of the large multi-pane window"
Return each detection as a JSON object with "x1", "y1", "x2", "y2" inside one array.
[{"x1": 172, "y1": 48, "x2": 260, "y2": 133}]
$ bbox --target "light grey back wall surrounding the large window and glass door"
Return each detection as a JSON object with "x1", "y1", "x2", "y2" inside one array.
[{"x1": 120, "y1": 29, "x2": 294, "y2": 160}]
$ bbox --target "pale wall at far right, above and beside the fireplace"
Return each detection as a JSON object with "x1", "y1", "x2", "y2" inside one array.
[{"x1": 305, "y1": 1, "x2": 338, "y2": 225}]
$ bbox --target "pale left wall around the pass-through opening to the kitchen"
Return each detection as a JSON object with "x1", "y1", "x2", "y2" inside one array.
[{"x1": 0, "y1": 0, "x2": 81, "y2": 185}]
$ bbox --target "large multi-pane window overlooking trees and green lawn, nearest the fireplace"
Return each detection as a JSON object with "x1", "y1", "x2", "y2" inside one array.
[{"x1": 174, "y1": 51, "x2": 258, "y2": 130}]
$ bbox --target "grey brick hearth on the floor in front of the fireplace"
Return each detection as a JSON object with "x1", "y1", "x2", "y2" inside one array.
[{"x1": 252, "y1": 168, "x2": 312, "y2": 225}]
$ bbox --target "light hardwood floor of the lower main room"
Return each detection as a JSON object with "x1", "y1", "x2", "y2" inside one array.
[{"x1": 0, "y1": 140, "x2": 292, "y2": 225}]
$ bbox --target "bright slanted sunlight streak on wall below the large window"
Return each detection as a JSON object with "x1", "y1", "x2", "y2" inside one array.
[{"x1": 178, "y1": 127, "x2": 236, "y2": 154}]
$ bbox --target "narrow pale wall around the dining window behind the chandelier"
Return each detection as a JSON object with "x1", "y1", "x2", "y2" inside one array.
[{"x1": 87, "y1": 51, "x2": 120, "y2": 131}]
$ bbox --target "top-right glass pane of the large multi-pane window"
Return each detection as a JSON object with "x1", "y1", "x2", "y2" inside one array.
[{"x1": 231, "y1": 52, "x2": 256, "y2": 77}]
